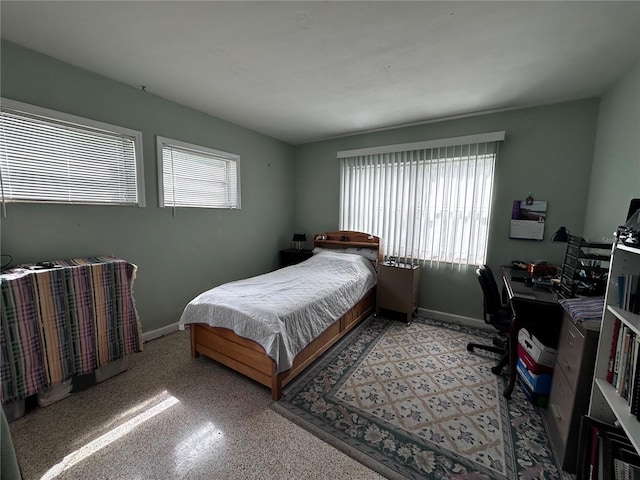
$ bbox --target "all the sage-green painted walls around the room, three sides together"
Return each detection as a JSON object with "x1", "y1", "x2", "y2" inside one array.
[{"x1": 0, "y1": 41, "x2": 640, "y2": 332}]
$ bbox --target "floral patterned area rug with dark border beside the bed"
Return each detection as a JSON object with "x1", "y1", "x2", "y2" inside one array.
[{"x1": 273, "y1": 317, "x2": 569, "y2": 480}]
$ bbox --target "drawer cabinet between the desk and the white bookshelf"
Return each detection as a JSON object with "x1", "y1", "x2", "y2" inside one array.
[{"x1": 546, "y1": 312, "x2": 598, "y2": 473}]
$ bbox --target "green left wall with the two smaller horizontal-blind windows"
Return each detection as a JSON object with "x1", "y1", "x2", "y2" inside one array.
[{"x1": 0, "y1": 41, "x2": 293, "y2": 332}]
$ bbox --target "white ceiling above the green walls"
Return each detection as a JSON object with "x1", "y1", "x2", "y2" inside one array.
[{"x1": 0, "y1": 0, "x2": 640, "y2": 144}]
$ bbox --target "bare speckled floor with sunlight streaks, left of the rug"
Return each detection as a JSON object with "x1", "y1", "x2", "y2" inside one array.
[{"x1": 3, "y1": 331, "x2": 382, "y2": 480}]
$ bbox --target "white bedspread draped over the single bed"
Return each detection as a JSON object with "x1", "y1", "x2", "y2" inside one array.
[{"x1": 179, "y1": 251, "x2": 376, "y2": 373}]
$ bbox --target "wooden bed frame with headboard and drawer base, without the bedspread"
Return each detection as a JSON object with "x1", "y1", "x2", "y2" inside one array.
[{"x1": 189, "y1": 230, "x2": 382, "y2": 400}]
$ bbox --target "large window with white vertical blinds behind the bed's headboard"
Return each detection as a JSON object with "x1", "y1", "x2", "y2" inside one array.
[{"x1": 338, "y1": 132, "x2": 504, "y2": 266}]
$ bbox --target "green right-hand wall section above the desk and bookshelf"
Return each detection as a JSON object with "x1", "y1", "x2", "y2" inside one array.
[{"x1": 584, "y1": 64, "x2": 640, "y2": 241}]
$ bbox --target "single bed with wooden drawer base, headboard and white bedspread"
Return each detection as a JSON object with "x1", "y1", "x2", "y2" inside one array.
[{"x1": 179, "y1": 231, "x2": 382, "y2": 400}]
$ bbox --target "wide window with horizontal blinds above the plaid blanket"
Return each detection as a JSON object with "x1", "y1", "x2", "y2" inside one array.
[{"x1": 0, "y1": 99, "x2": 144, "y2": 207}]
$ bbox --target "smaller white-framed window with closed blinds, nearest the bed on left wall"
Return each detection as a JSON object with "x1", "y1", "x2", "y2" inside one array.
[{"x1": 157, "y1": 137, "x2": 240, "y2": 208}]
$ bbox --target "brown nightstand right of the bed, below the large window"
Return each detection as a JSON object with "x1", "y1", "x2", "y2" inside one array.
[{"x1": 376, "y1": 262, "x2": 420, "y2": 325}]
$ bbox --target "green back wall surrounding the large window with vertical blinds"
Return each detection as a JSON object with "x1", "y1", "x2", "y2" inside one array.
[{"x1": 295, "y1": 99, "x2": 598, "y2": 318}]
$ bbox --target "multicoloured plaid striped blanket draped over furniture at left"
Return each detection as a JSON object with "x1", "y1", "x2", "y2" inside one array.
[{"x1": 0, "y1": 257, "x2": 142, "y2": 403}]
